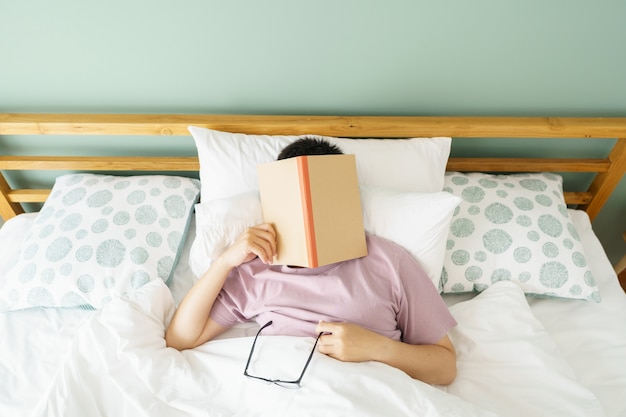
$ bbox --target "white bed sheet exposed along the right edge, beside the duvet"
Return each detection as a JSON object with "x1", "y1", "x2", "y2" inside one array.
[{"x1": 529, "y1": 210, "x2": 626, "y2": 416}]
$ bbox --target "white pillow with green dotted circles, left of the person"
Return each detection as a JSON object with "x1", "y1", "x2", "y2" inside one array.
[{"x1": 0, "y1": 174, "x2": 200, "y2": 311}]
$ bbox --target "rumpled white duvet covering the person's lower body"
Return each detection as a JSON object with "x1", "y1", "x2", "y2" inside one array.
[{"x1": 33, "y1": 280, "x2": 604, "y2": 417}]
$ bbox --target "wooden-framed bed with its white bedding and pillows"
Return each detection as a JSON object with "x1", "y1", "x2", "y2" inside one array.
[{"x1": 0, "y1": 114, "x2": 626, "y2": 417}]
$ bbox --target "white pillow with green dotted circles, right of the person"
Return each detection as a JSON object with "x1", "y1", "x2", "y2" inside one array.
[{"x1": 441, "y1": 172, "x2": 600, "y2": 302}]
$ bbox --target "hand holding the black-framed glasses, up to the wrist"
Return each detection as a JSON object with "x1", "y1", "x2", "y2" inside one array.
[{"x1": 316, "y1": 321, "x2": 387, "y2": 362}]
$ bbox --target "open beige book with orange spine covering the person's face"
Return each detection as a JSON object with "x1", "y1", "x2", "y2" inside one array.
[{"x1": 258, "y1": 155, "x2": 367, "y2": 268}]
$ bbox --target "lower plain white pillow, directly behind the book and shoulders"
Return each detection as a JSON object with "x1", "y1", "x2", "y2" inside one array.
[{"x1": 190, "y1": 186, "x2": 461, "y2": 288}]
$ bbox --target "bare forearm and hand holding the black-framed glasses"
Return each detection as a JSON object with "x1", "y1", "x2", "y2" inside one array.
[{"x1": 316, "y1": 322, "x2": 456, "y2": 385}]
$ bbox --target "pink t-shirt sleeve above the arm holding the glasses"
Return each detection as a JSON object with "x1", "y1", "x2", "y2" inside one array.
[{"x1": 397, "y1": 247, "x2": 456, "y2": 344}]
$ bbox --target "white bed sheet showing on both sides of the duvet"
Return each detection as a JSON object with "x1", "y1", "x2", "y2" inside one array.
[{"x1": 0, "y1": 211, "x2": 626, "y2": 417}]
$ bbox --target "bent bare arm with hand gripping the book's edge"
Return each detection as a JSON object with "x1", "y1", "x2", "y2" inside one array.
[{"x1": 165, "y1": 224, "x2": 276, "y2": 350}]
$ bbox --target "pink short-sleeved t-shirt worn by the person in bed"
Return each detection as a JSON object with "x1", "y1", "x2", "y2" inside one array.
[{"x1": 210, "y1": 235, "x2": 456, "y2": 344}]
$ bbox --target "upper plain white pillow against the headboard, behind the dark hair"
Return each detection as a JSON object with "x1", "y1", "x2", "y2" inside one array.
[{"x1": 189, "y1": 126, "x2": 451, "y2": 203}]
